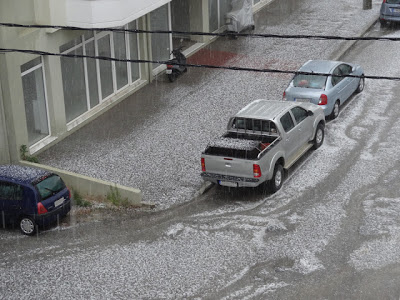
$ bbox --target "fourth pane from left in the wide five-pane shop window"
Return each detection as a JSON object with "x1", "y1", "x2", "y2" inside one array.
[{"x1": 113, "y1": 32, "x2": 128, "y2": 90}]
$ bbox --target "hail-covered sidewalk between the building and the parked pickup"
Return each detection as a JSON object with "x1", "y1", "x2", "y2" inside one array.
[{"x1": 39, "y1": 0, "x2": 381, "y2": 209}]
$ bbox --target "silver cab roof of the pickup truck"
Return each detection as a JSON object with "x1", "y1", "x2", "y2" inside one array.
[{"x1": 235, "y1": 99, "x2": 299, "y2": 120}]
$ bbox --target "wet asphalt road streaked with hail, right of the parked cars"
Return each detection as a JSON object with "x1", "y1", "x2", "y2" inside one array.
[{"x1": 0, "y1": 1, "x2": 400, "y2": 299}]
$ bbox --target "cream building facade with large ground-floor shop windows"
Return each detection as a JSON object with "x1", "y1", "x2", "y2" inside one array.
[{"x1": 0, "y1": 0, "x2": 268, "y2": 164}]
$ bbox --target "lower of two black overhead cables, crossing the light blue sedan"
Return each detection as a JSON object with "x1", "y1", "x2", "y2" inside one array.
[{"x1": 0, "y1": 48, "x2": 400, "y2": 81}]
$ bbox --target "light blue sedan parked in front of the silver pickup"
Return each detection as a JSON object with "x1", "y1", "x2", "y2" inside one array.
[{"x1": 283, "y1": 60, "x2": 364, "y2": 119}]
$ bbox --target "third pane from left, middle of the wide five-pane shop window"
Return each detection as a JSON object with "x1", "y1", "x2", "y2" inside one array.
[{"x1": 97, "y1": 34, "x2": 114, "y2": 99}]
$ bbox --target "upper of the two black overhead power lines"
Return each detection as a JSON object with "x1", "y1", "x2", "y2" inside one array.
[{"x1": 0, "y1": 23, "x2": 400, "y2": 42}]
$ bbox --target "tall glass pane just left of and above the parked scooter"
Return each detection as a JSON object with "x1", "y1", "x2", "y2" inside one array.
[{"x1": 150, "y1": 4, "x2": 171, "y2": 68}]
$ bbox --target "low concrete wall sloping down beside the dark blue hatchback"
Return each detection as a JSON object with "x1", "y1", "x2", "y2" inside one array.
[{"x1": 20, "y1": 161, "x2": 145, "y2": 206}]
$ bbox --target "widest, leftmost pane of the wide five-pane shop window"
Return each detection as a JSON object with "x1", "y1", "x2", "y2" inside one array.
[{"x1": 61, "y1": 46, "x2": 88, "y2": 122}]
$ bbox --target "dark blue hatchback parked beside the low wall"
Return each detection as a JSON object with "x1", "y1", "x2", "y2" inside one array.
[{"x1": 0, "y1": 165, "x2": 71, "y2": 235}]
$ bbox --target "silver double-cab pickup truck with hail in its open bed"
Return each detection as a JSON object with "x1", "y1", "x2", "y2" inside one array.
[{"x1": 201, "y1": 99, "x2": 325, "y2": 192}]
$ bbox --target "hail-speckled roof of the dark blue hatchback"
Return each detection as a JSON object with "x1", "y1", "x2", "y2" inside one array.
[{"x1": 0, "y1": 165, "x2": 52, "y2": 183}]
